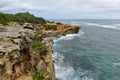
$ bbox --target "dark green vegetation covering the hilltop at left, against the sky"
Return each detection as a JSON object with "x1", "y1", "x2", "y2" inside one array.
[{"x1": 0, "y1": 12, "x2": 46, "y2": 25}]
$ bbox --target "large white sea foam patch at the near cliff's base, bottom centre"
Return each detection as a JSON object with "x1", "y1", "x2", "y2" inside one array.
[{"x1": 53, "y1": 52, "x2": 94, "y2": 80}]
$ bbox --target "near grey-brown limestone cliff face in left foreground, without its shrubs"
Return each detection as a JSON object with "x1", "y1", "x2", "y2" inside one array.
[{"x1": 0, "y1": 26, "x2": 56, "y2": 80}]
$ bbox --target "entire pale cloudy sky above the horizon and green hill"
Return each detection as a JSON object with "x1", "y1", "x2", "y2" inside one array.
[{"x1": 0, "y1": 0, "x2": 120, "y2": 19}]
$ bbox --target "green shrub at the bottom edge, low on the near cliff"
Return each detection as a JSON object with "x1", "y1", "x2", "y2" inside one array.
[{"x1": 33, "y1": 71, "x2": 49, "y2": 80}]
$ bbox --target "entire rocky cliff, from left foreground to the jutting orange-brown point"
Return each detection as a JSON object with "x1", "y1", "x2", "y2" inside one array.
[{"x1": 0, "y1": 23, "x2": 79, "y2": 80}]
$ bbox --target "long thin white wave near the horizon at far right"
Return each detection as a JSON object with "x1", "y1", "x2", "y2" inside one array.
[{"x1": 84, "y1": 23, "x2": 120, "y2": 29}]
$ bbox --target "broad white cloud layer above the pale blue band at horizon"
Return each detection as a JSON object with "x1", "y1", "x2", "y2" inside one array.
[{"x1": 0, "y1": 0, "x2": 120, "y2": 16}]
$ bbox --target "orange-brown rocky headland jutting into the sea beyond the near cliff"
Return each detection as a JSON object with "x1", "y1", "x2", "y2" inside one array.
[{"x1": 42, "y1": 23, "x2": 80, "y2": 37}]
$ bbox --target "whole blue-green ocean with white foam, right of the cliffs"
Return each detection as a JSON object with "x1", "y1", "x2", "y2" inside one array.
[{"x1": 53, "y1": 19, "x2": 120, "y2": 80}]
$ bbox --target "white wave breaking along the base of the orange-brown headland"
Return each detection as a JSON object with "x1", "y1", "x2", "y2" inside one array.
[{"x1": 54, "y1": 30, "x2": 84, "y2": 42}]
